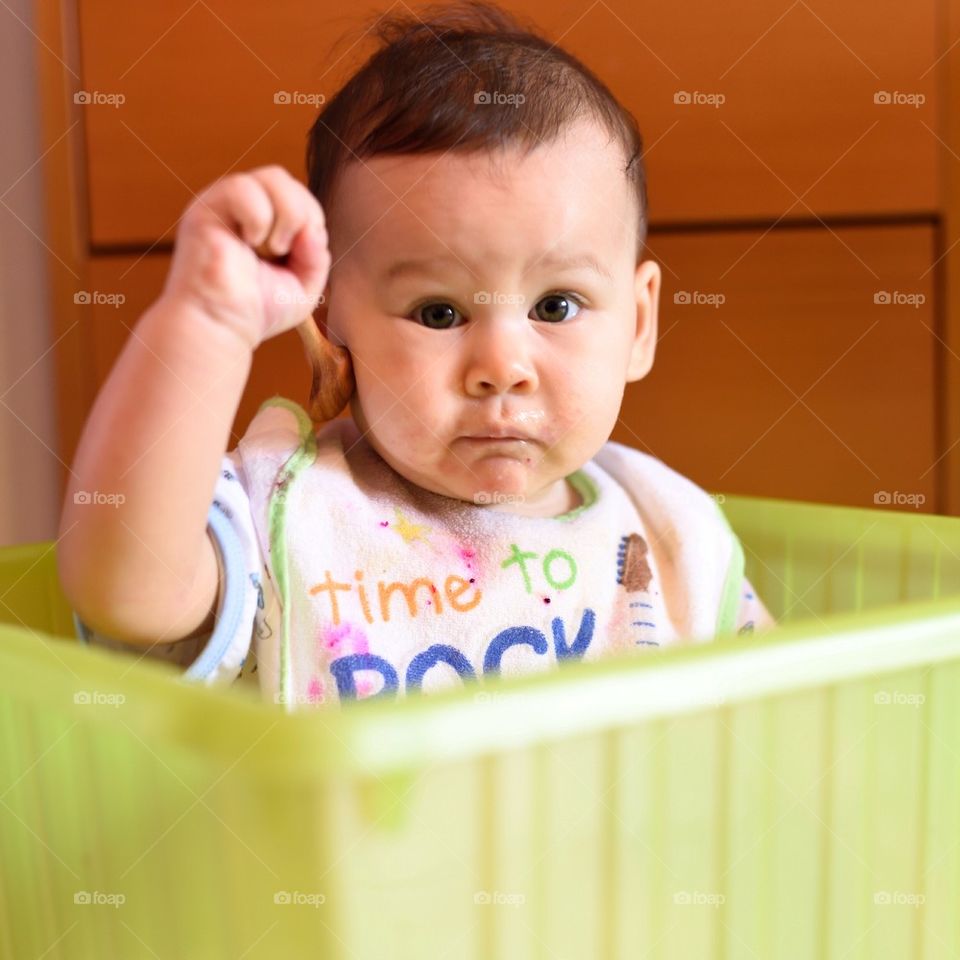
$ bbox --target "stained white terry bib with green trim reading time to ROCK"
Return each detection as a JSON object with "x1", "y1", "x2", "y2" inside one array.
[{"x1": 235, "y1": 397, "x2": 744, "y2": 709}]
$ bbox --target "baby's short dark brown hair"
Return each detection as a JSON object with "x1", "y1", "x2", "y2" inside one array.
[{"x1": 307, "y1": 0, "x2": 647, "y2": 263}]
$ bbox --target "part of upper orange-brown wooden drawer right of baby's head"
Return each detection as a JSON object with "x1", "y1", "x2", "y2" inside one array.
[{"x1": 564, "y1": 0, "x2": 939, "y2": 223}]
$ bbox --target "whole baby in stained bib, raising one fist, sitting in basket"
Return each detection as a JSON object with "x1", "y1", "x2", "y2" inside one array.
[{"x1": 58, "y1": 4, "x2": 773, "y2": 709}]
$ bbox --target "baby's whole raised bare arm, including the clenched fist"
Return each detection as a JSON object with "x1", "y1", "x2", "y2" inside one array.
[{"x1": 57, "y1": 167, "x2": 330, "y2": 646}]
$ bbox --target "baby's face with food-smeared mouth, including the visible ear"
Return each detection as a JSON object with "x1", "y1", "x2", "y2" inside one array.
[{"x1": 317, "y1": 121, "x2": 660, "y2": 516}]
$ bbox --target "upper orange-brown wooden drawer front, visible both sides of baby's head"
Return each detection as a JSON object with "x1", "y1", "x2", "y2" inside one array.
[{"x1": 75, "y1": 0, "x2": 938, "y2": 246}]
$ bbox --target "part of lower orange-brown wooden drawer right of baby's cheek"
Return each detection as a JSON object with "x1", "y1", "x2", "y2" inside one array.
[{"x1": 613, "y1": 225, "x2": 938, "y2": 511}]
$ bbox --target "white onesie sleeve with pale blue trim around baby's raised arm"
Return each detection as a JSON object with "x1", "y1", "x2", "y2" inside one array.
[{"x1": 73, "y1": 453, "x2": 264, "y2": 685}]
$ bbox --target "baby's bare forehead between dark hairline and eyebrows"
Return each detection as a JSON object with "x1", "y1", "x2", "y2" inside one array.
[{"x1": 328, "y1": 125, "x2": 637, "y2": 259}]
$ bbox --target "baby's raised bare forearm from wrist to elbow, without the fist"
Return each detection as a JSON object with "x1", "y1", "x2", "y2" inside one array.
[{"x1": 57, "y1": 296, "x2": 252, "y2": 644}]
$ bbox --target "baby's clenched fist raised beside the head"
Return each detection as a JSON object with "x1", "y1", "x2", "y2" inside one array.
[{"x1": 163, "y1": 166, "x2": 330, "y2": 350}]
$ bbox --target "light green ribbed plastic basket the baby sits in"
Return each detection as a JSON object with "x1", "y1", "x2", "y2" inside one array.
[{"x1": 0, "y1": 496, "x2": 960, "y2": 960}]
